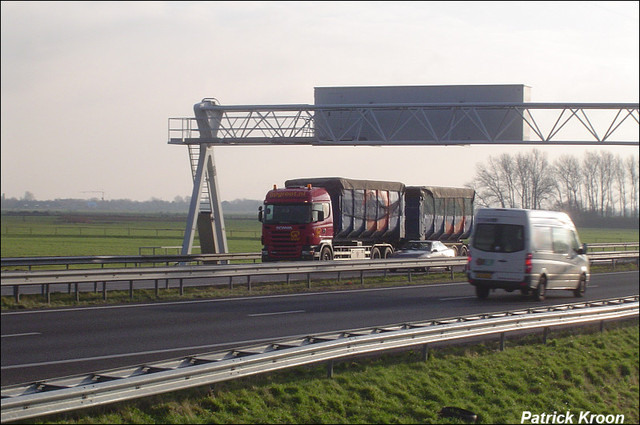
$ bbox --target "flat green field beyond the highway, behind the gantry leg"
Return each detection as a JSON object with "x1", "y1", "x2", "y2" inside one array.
[{"x1": 0, "y1": 214, "x2": 638, "y2": 258}]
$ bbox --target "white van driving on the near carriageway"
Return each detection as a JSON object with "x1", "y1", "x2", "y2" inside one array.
[{"x1": 467, "y1": 208, "x2": 589, "y2": 301}]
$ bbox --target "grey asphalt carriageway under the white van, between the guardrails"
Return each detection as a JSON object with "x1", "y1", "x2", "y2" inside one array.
[{"x1": 1, "y1": 271, "x2": 639, "y2": 387}]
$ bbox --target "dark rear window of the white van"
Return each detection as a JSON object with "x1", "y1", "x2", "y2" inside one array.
[{"x1": 472, "y1": 223, "x2": 524, "y2": 252}]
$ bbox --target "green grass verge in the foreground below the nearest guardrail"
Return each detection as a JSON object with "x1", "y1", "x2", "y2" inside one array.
[{"x1": 25, "y1": 320, "x2": 640, "y2": 424}]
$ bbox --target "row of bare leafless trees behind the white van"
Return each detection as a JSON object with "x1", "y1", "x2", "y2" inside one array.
[{"x1": 466, "y1": 149, "x2": 639, "y2": 218}]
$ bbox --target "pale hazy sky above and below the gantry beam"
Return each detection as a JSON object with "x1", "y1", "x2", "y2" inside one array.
[{"x1": 0, "y1": 1, "x2": 640, "y2": 201}]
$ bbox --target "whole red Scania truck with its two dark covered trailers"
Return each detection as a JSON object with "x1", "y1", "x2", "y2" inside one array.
[{"x1": 258, "y1": 177, "x2": 475, "y2": 262}]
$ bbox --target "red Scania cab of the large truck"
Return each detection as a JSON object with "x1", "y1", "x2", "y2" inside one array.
[{"x1": 259, "y1": 185, "x2": 333, "y2": 262}]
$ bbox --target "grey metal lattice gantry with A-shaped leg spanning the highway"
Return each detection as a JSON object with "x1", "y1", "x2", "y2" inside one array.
[{"x1": 169, "y1": 99, "x2": 640, "y2": 254}]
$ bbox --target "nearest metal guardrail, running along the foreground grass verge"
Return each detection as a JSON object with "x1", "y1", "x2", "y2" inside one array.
[{"x1": 1, "y1": 296, "x2": 639, "y2": 422}]
